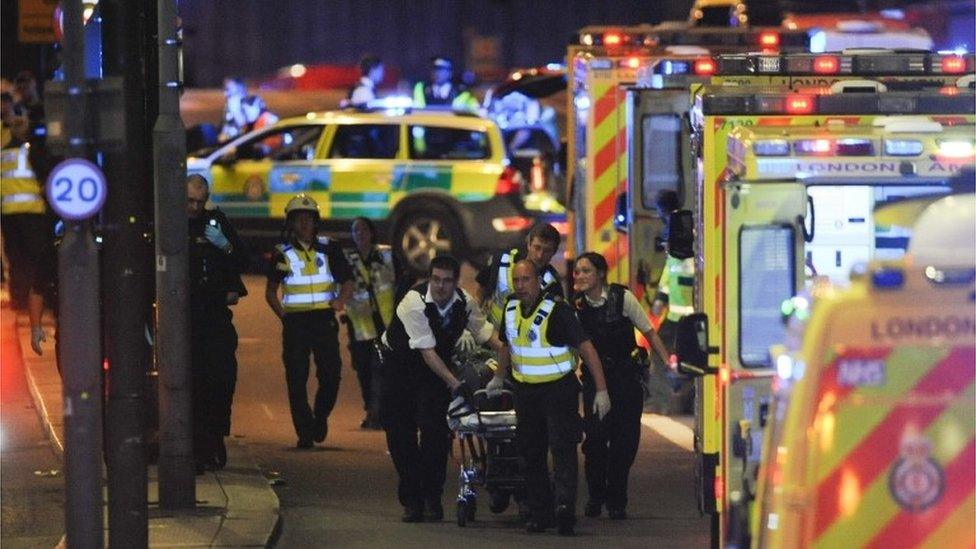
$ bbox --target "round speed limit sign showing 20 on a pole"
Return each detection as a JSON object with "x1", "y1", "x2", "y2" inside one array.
[{"x1": 47, "y1": 158, "x2": 108, "y2": 221}]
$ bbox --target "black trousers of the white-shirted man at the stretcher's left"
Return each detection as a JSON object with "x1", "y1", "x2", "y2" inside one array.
[{"x1": 380, "y1": 351, "x2": 451, "y2": 507}]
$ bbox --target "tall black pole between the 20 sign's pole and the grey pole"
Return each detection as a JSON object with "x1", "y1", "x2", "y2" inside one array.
[{"x1": 99, "y1": 0, "x2": 153, "y2": 549}]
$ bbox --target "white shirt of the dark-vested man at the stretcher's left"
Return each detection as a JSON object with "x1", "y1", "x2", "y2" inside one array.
[{"x1": 383, "y1": 288, "x2": 494, "y2": 349}]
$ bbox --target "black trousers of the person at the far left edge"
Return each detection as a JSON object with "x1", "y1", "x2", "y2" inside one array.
[{"x1": 2, "y1": 214, "x2": 51, "y2": 309}]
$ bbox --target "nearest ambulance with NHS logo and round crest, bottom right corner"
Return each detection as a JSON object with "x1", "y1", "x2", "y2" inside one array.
[{"x1": 752, "y1": 186, "x2": 976, "y2": 548}]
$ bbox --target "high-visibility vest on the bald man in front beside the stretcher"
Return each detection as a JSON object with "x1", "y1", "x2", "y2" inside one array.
[{"x1": 505, "y1": 298, "x2": 575, "y2": 383}]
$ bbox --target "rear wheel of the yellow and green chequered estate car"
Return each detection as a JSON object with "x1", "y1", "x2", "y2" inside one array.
[{"x1": 392, "y1": 208, "x2": 465, "y2": 275}]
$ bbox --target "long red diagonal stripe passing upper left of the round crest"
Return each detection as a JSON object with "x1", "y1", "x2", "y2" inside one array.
[{"x1": 814, "y1": 347, "x2": 976, "y2": 539}]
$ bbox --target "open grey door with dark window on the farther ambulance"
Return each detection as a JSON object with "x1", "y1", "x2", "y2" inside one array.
[{"x1": 616, "y1": 88, "x2": 697, "y2": 305}]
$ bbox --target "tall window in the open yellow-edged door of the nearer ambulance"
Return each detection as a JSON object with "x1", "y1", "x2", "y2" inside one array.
[{"x1": 739, "y1": 225, "x2": 796, "y2": 368}]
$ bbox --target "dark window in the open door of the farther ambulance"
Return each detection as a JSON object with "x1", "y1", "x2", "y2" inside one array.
[{"x1": 641, "y1": 114, "x2": 682, "y2": 210}]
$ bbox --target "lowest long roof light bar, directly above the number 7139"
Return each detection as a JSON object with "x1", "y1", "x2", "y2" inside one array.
[{"x1": 701, "y1": 90, "x2": 976, "y2": 115}]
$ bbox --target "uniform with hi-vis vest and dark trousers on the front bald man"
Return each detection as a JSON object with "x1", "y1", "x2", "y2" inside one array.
[{"x1": 500, "y1": 295, "x2": 589, "y2": 522}]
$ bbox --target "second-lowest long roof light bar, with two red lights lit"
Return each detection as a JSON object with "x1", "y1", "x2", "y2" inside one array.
[{"x1": 716, "y1": 51, "x2": 976, "y2": 76}]
